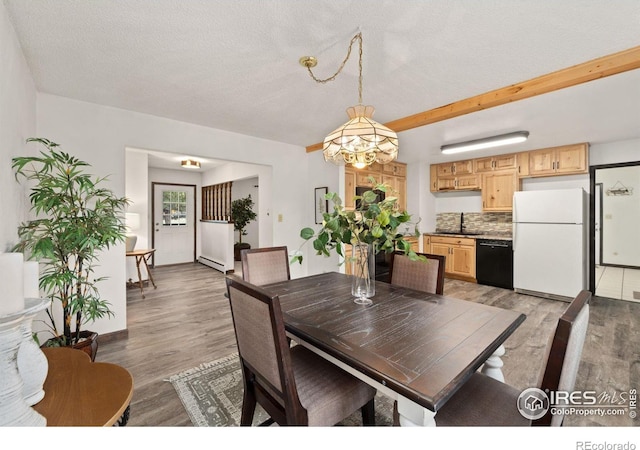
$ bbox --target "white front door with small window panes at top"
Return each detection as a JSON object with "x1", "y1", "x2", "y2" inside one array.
[{"x1": 153, "y1": 183, "x2": 196, "y2": 266}]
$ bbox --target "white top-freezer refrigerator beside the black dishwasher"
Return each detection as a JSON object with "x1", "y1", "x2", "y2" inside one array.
[{"x1": 513, "y1": 188, "x2": 588, "y2": 301}]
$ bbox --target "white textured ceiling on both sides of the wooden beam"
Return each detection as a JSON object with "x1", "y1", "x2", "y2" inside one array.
[{"x1": 4, "y1": 0, "x2": 640, "y2": 162}]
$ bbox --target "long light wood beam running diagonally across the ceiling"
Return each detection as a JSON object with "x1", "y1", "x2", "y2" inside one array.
[{"x1": 307, "y1": 46, "x2": 640, "y2": 153}]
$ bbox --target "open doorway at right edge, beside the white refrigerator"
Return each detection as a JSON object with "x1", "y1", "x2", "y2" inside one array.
[{"x1": 589, "y1": 161, "x2": 640, "y2": 302}]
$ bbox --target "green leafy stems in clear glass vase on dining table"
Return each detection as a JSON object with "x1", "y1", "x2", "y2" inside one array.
[{"x1": 291, "y1": 177, "x2": 426, "y2": 305}]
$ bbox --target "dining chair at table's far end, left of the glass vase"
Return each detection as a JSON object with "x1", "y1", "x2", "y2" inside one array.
[{"x1": 240, "y1": 246, "x2": 291, "y2": 286}]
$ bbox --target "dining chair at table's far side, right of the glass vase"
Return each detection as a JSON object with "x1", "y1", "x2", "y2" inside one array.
[{"x1": 390, "y1": 252, "x2": 445, "y2": 295}]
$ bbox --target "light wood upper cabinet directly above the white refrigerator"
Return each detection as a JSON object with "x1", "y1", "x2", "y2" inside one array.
[{"x1": 528, "y1": 144, "x2": 589, "y2": 177}]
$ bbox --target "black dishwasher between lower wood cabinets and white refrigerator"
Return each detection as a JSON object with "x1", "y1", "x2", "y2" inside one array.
[{"x1": 476, "y1": 239, "x2": 513, "y2": 289}]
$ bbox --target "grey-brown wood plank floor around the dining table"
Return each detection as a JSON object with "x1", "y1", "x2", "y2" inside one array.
[{"x1": 96, "y1": 263, "x2": 640, "y2": 426}]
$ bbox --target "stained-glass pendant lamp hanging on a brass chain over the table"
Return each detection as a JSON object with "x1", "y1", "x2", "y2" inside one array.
[{"x1": 300, "y1": 33, "x2": 398, "y2": 169}]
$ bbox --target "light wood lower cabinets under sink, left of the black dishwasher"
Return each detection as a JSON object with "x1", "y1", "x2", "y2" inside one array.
[{"x1": 425, "y1": 236, "x2": 476, "y2": 281}]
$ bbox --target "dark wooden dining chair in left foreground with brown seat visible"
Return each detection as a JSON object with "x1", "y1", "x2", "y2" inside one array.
[{"x1": 226, "y1": 275, "x2": 376, "y2": 426}]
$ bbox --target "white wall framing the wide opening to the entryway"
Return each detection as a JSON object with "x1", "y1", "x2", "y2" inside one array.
[{"x1": 37, "y1": 93, "x2": 318, "y2": 333}]
